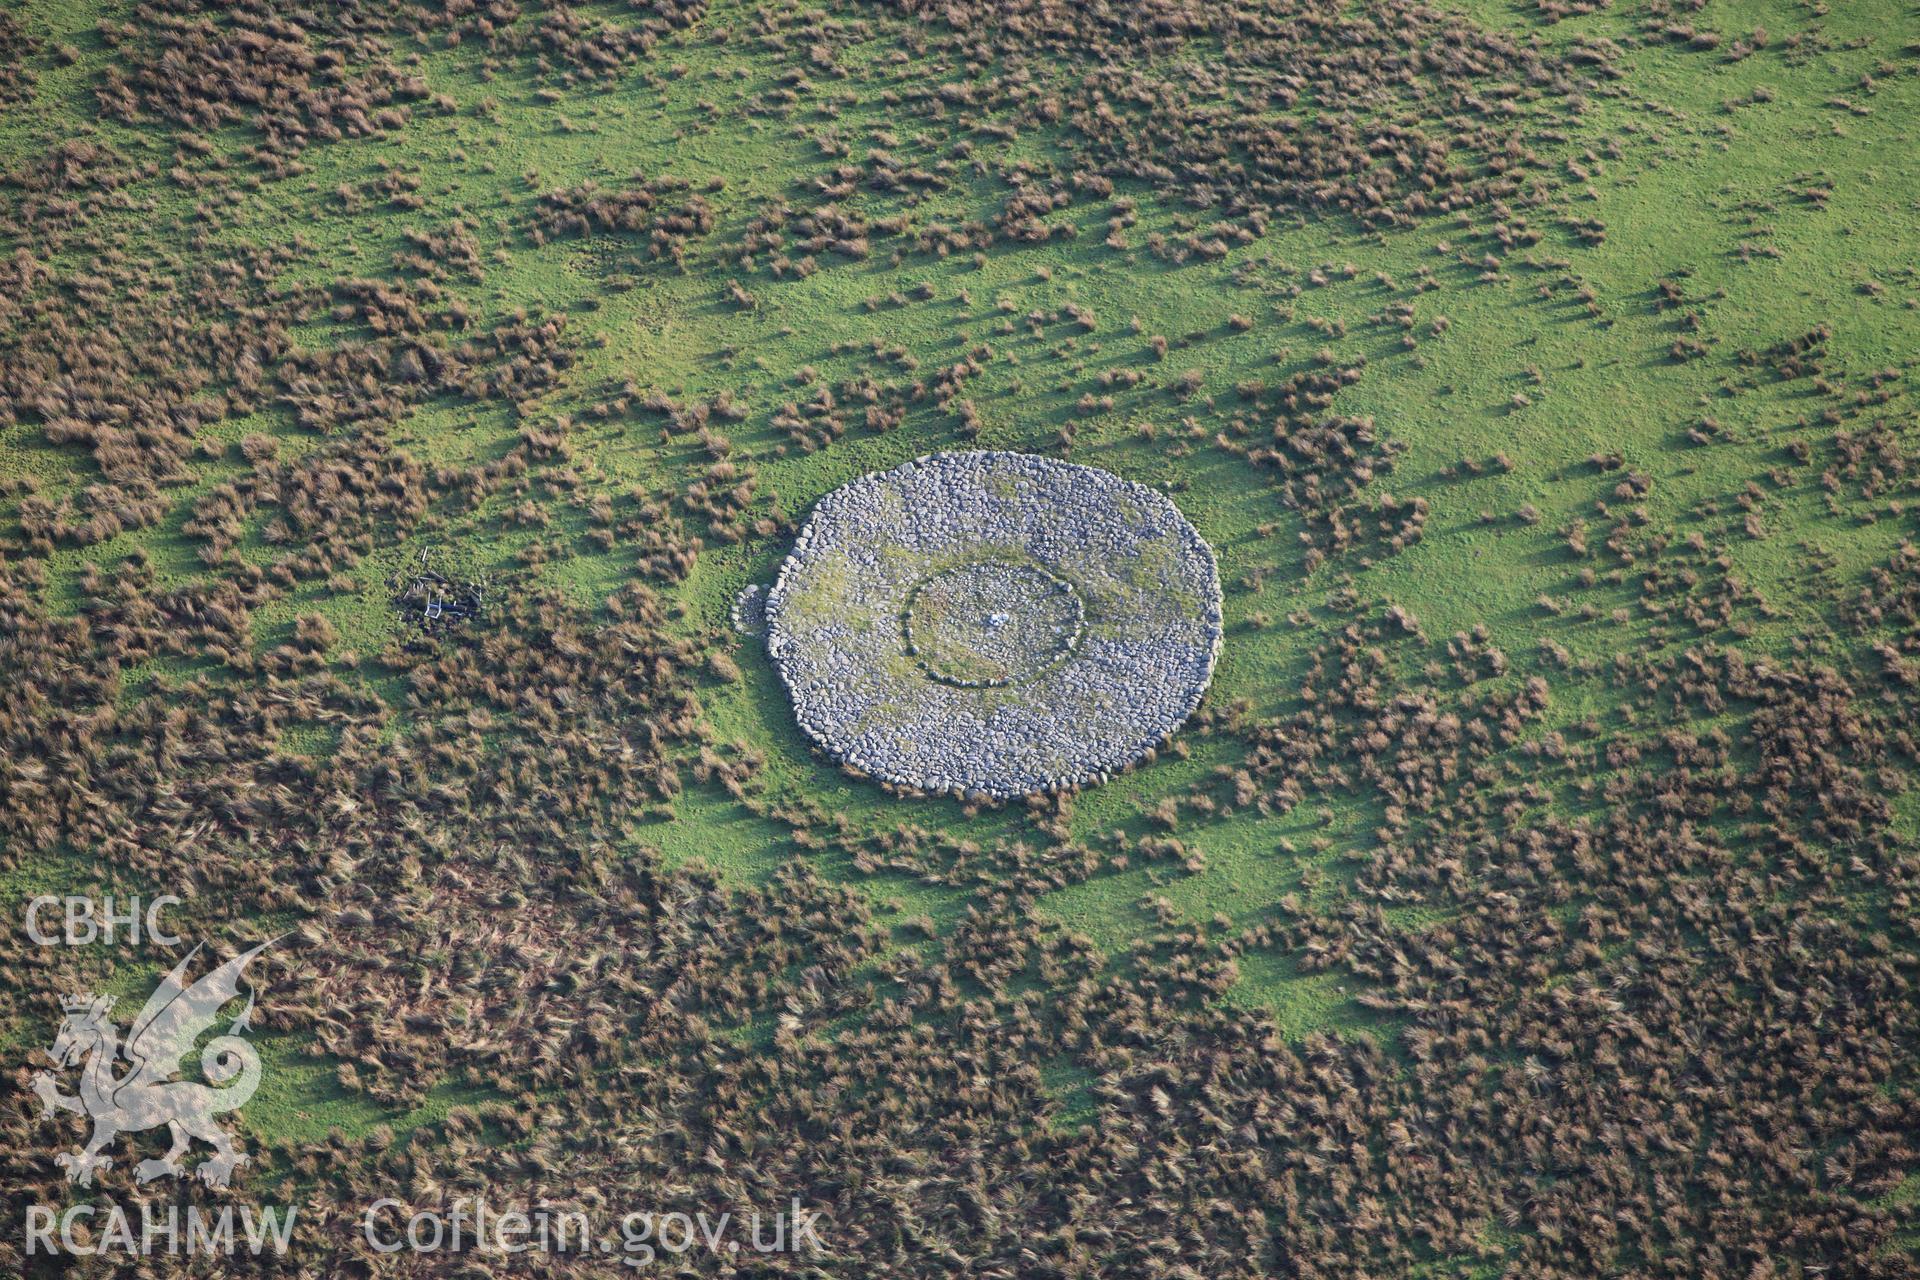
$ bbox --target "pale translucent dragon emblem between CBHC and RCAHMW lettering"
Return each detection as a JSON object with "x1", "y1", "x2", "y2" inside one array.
[{"x1": 33, "y1": 938, "x2": 278, "y2": 1186}]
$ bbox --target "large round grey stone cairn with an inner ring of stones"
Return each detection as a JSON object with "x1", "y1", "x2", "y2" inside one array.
[{"x1": 749, "y1": 451, "x2": 1221, "y2": 800}]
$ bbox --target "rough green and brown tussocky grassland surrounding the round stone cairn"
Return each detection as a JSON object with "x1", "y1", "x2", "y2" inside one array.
[{"x1": 0, "y1": 0, "x2": 1920, "y2": 1276}]
